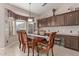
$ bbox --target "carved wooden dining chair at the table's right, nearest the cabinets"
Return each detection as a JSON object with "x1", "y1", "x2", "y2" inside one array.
[{"x1": 38, "y1": 32, "x2": 56, "y2": 56}]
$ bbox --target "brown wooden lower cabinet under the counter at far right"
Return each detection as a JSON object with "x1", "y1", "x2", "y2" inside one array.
[{"x1": 64, "y1": 36, "x2": 79, "y2": 50}]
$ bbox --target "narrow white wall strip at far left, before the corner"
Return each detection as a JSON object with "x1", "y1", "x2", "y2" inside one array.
[{"x1": 0, "y1": 4, "x2": 5, "y2": 48}]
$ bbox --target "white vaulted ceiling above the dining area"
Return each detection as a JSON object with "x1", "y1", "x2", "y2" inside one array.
[{"x1": 10, "y1": 3, "x2": 79, "y2": 15}]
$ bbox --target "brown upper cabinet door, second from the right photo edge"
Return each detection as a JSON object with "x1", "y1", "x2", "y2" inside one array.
[{"x1": 65, "y1": 12, "x2": 76, "y2": 26}]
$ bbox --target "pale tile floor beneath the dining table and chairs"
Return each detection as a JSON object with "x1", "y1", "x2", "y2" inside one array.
[{"x1": 0, "y1": 42, "x2": 79, "y2": 56}]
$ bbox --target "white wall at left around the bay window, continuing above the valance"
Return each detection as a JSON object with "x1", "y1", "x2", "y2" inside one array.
[{"x1": 0, "y1": 3, "x2": 36, "y2": 48}]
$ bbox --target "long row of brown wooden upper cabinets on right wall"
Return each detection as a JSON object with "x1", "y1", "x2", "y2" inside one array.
[{"x1": 38, "y1": 10, "x2": 79, "y2": 27}]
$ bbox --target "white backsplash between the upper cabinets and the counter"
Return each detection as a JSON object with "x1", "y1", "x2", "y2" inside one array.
[{"x1": 40, "y1": 25, "x2": 79, "y2": 36}]
